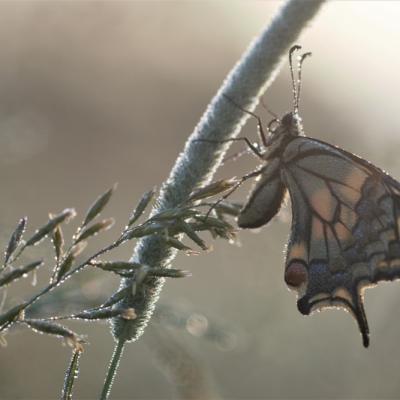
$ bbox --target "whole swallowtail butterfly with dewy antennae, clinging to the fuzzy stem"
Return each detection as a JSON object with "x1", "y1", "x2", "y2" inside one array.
[{"x1": 227, "y1": 45, "x2": 400, "y2": 347}]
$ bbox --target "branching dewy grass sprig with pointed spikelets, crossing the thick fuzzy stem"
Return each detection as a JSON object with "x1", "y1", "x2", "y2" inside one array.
[{"x1": 0, "y1": 177, "x2": 244, "y2": 399}]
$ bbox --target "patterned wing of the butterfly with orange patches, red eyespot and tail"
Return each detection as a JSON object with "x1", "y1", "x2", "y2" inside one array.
[{"x1": 282, "y1": 138, "x2": 400, "y2": 347}]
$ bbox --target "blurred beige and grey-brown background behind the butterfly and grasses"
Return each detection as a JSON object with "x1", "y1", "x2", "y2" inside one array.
[{"x1": 0, "y1": 1, "x2": 400, "y2": 399}]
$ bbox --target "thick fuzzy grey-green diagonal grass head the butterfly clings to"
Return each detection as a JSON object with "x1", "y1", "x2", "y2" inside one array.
[{"x1": 104, "y1": 0, "x2": 324, "y2": 399}]
